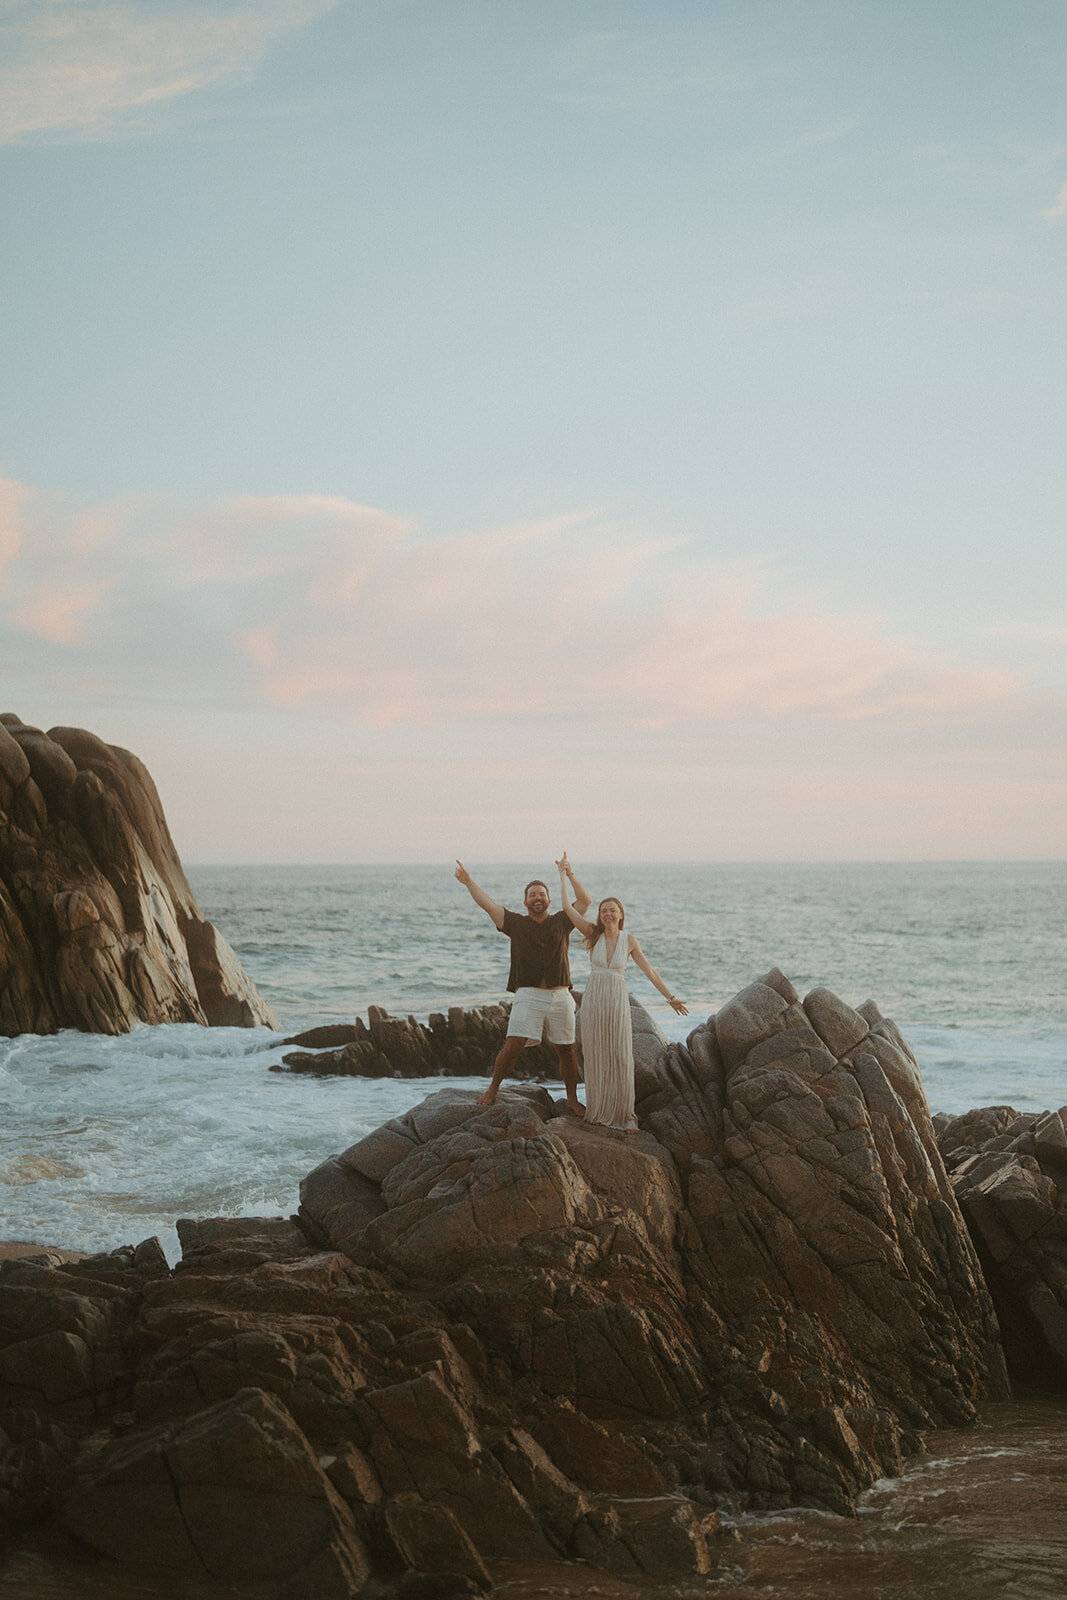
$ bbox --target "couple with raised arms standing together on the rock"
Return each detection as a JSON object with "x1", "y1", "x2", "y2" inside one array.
[{"x1": 456, "y1": 851, "x2": 688, "y2": 1133}]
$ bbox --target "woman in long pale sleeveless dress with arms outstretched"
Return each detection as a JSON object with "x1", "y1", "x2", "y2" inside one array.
[{"x1": 557, "y1": 851, "x2": 689, "y2": 1133}]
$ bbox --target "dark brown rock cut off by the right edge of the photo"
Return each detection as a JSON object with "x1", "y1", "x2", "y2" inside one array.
[{"x1": 934, "y1": 1106, "x2": 1067, "y2": 1389}]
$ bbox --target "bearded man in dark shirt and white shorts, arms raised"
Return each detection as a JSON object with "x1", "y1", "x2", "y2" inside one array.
[{"x1": 456, "y1": 854, "x2": 592, "y2": 1117}]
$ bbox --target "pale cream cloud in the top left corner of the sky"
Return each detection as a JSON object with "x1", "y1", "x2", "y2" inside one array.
[{"x1": 0, "y1": 0, "x2": 338, "y2": 142}]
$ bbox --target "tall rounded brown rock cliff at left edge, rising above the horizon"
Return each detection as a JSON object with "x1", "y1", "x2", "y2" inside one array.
[{"x1": 0, "y1": 714, "x2": 277, "y2": 1035}]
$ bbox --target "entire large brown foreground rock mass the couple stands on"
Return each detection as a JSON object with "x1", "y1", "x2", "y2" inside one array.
[{"x1": 0, "y1": 973, "x2": 1006, "y2": 1600}]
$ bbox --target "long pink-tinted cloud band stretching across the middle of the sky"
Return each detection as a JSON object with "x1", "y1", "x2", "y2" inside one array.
[{"x1": 0, "y1": 470, "x2": 1024, "y2": 730}]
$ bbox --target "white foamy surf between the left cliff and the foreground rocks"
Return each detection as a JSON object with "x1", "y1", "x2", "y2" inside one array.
[{"x1": 0, "y1": 1024, "x2": 483, "y2": 1259}]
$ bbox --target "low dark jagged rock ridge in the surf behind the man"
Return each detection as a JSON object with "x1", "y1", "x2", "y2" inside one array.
[{"x1": 283, "y1": 1003, "x2": 560, "y2": 1078}]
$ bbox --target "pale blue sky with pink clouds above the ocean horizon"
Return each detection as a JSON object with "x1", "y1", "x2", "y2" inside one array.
[{"x1": 0, "y1": 0, "x2": 1067, "y2": 870}]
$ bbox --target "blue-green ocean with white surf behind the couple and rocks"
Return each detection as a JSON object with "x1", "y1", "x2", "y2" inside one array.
[{"x1": 0, "y1": 862, "x2": 1067, "y2": 1261}]
